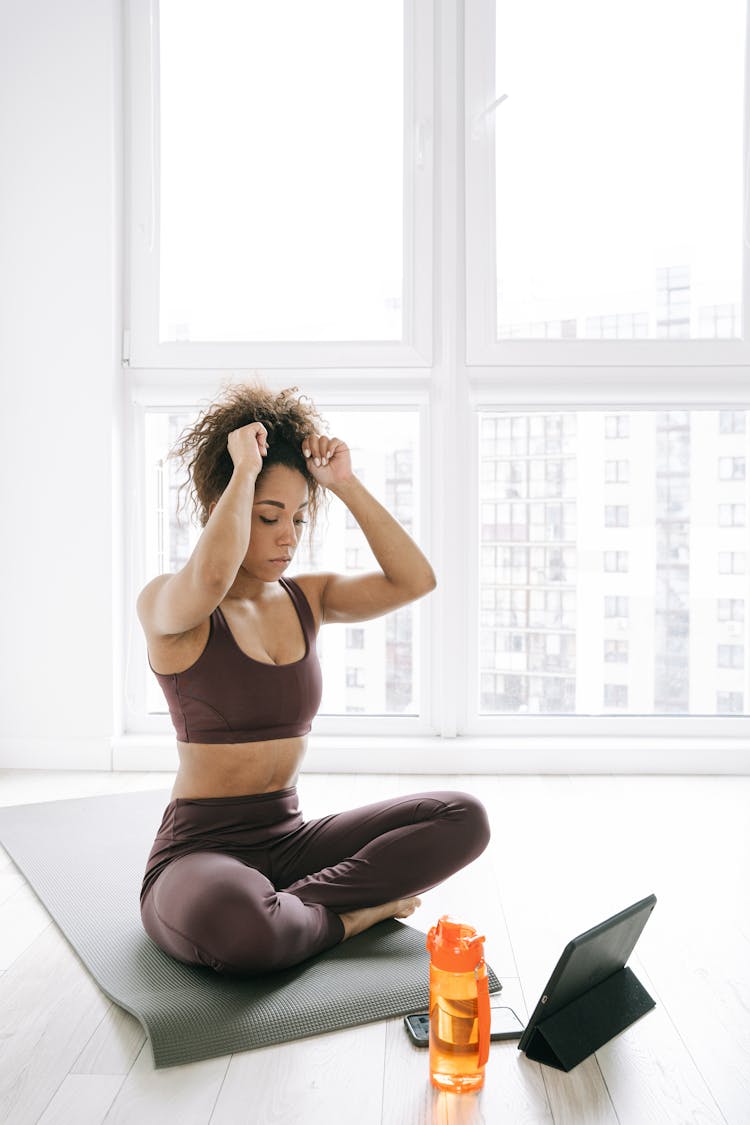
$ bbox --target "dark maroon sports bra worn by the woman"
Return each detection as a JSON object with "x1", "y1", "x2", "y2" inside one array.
[{"x1": 148, "y1": 578, "x2": 323, "y2": 744}]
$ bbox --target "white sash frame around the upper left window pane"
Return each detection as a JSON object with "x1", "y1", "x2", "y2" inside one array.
[{"x1": 123, "y1": 0, "x2": 434, "y2": 377}]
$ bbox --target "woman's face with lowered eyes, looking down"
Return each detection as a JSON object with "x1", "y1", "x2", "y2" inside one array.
[{"x1": 243, "y1": 465, "x2": 308, "y2": 582}]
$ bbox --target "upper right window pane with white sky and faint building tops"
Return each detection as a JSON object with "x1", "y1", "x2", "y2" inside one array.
[{"x1": 495, "y1": 0, "x2": 746, "y2": 340}]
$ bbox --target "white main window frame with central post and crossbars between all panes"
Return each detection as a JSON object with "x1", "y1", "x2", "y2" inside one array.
[{"x1": 115, "y1": 0, "x2": 750, "y2": 773}]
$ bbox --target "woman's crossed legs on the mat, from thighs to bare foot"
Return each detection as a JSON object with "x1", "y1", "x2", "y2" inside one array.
[{"x1": 143, "y1": 791, "x2": 489, "y2": 973}]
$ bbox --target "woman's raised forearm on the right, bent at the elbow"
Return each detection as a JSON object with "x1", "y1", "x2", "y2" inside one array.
[{"x1": 328, "y1": 476, "x2": 436, "y2": 599}]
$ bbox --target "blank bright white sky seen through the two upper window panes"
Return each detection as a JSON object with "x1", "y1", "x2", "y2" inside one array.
[{"x1": 160, "y1": 0, "x2": 746, "y2": 340}]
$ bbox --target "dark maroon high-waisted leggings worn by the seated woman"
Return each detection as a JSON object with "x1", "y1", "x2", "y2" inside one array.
[{"x1": 142, "y1": 788, "x2": 489, "y2": 974}]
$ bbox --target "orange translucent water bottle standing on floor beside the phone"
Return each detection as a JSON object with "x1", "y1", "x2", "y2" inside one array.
[{"x1": 427, "y1": 915, "x2": 490, "y2": 1092}]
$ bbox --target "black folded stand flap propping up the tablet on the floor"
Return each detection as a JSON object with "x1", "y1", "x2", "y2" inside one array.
[{"x1": 526, "y1": 968, "x2": 657, "y2": 1071}]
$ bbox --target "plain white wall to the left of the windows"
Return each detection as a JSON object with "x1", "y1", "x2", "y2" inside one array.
[{"x1": 0, "y1": 0, "x2": 121, "y2": 768}]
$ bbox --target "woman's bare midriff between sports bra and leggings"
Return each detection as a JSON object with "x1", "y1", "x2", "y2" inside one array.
[{"x1": 172, "y1": 737, "x2": 307, "y2": 800}]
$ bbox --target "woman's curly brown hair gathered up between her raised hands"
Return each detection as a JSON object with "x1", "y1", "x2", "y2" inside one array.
[{"x1": 169, "y1": 383, "x2": 325, "y2": 532}]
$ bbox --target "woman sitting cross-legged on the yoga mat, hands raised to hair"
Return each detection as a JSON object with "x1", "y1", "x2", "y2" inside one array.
[{"x1": 137, "y1": 386, "x2": 489, "y2": 973}]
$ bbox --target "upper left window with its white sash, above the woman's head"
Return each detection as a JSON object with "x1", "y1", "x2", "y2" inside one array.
[{"x1": 129, "y1": 0, "x2": 432, "y2": 368}]
